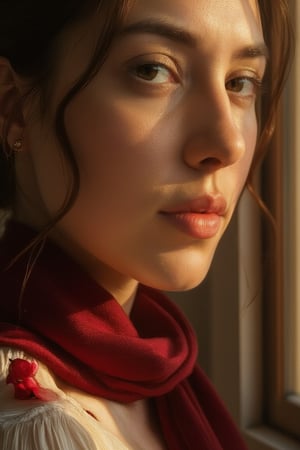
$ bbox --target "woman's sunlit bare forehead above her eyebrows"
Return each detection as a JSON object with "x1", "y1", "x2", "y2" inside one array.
[{"x1": 126, "y1": 0, "x2": 263, "y2": 46}]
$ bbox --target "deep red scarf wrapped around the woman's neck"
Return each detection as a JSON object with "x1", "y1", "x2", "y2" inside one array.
[{"x1": 0, "y1": 223, "x2": 246, "y2": 450}]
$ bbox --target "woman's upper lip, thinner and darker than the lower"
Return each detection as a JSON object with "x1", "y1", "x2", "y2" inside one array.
[{"x1": 161, "y1": 194, "x2": 227, "y2": 216}]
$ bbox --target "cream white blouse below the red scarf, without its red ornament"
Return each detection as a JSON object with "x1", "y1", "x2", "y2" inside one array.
[{"x1": 0, "y1": 348, "x2": 130, "y2": 450}]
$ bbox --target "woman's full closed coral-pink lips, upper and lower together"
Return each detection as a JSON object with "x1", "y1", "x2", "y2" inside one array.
[{"x1": 161, "y1": 195, "x2": 227, "y2": 239}]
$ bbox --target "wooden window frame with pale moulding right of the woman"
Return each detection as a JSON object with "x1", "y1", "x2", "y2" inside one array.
[{"x1": 209, "y1": 0, "x2": 300, "y2": 440}]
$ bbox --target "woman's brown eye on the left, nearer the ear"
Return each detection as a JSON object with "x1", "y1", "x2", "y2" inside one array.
[{"x1": 132, "y1": 62, "x2": 175, "y2": 84}]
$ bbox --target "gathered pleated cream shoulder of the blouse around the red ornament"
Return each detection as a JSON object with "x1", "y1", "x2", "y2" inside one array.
[{"x1": 0, "y1": 348, "x2": 96, "y2": 450}]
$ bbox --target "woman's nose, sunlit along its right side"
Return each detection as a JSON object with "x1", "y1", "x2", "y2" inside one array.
[{"x1": 183, "y1": 87, "x2": 246, "y2": 170}]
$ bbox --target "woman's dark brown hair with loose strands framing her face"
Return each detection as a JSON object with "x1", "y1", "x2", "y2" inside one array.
[{"x1": 0, "y1": 0, "x2": 292, "y2": 225}]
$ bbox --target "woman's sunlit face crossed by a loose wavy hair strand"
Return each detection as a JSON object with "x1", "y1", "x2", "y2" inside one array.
[{"x1": 18, "y1": 0, "x2": 266, "y2": 290}]
